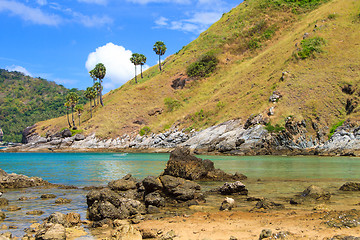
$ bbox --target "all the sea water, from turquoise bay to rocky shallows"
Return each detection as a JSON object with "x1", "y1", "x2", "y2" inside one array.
[{"x1": 0, "y1": 153, "x2": 360, "y2": 236}]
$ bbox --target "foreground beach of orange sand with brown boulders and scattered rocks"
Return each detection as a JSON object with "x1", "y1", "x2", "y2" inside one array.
[{"x1": 0, "y1": 148, "x2": 360, "y2": 240}]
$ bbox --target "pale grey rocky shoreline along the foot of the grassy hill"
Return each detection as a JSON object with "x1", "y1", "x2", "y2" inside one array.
[{"x1": 2, "y1": 115, "x2": 360, "y2": 156}]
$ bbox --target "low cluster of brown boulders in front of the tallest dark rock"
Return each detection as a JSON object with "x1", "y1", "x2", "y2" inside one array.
[{"x1": 86, "y1": 172, "x2": 204, "y2": 221}]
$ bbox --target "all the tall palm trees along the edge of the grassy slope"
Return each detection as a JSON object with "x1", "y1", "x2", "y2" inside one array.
[{"x1": 65, "y1": 41, "x2": 166, "y2": 129}]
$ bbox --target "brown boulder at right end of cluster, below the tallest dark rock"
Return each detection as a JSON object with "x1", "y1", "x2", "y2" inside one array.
[{"x1": 160, "y1": 175, "x2": 203, "y2": 201}]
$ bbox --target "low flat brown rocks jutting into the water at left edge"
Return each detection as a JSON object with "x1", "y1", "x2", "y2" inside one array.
[{"x1": 0, "y1": 169, "x2": 52, "y2": 188}]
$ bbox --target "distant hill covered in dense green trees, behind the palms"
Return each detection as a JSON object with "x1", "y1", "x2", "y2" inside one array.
[{"x1": 0, "y1": 69, "x2": 86, "y2": 142}]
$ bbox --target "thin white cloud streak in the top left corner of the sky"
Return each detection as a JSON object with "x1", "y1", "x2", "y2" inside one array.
[{"x1": 0, "y1": 0, "x2": 62, "y2": 26}]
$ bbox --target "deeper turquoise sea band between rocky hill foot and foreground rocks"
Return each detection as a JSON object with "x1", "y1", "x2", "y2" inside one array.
[{"x1": 0, "y1": 153, "x2": 360, "y2": 186}]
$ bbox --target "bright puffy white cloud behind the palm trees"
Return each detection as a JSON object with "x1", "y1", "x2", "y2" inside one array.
[{"x1": 85, "y1": 42, "x2": 138, "y2": 92}]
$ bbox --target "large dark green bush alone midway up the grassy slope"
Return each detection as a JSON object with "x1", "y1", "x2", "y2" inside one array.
[{"x1": 186, "y1": 52, "x2": 219, "y2": 77}]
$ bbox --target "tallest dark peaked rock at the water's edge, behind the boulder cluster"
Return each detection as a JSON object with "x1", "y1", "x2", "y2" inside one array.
[{"x1": 163, "y1": 147, "x2": 246, "y2": 181}]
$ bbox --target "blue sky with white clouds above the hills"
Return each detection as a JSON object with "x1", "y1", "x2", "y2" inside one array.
[{"x1": 0, "y1": 0, "x2": 241, "y2": 92}]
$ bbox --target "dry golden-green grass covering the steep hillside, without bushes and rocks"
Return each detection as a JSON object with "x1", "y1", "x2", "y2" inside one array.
[{"x1": 38, "y1": 0, "x2": 360, "y2": 137}]
